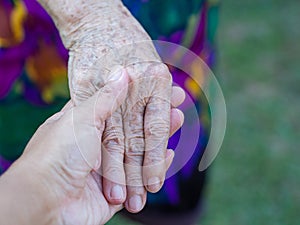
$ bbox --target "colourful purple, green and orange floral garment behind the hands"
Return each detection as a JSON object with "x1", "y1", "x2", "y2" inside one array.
[{"x1": 0, "y1": 0, "x2": 218, "y2": 210}]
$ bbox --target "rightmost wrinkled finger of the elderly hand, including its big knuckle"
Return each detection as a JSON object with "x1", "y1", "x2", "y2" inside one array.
[{"x1": 143, "y1": 66, "x2": 172, "y2": 193}]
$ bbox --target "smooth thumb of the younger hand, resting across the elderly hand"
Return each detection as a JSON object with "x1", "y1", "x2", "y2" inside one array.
[{"x1": 72, "y1": 69, "x2": 128, "y2": 169}]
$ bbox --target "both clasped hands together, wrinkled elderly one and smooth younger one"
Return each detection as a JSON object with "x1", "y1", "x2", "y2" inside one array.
[{"x1": 0, "y1": 0, "x2": 185, "y2": 225}]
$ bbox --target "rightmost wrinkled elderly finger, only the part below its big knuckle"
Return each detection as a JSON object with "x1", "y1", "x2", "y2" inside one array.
[{"x1": 143, "y1": 97, "x2": 170, "y2": 192}]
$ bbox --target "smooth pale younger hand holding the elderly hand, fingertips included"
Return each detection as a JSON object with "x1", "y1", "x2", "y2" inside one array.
[{"x1": 0, "y1": 70, "x2": 184, "y2": 225}]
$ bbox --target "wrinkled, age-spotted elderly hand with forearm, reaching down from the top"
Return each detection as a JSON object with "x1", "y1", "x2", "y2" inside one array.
[{"x1": 39, "y1": 0, "x2": 179, "y2": 212}]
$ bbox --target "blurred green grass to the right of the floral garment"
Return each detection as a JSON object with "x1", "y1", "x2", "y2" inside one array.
[{"x1": 109, "y1": 0, "x2": 300, "y2": 225}]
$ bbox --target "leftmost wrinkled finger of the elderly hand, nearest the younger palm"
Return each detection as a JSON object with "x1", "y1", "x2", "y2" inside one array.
[{"x1": 102, "y1": 108, "x2": 126, "y2": 204}]
